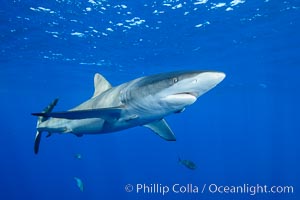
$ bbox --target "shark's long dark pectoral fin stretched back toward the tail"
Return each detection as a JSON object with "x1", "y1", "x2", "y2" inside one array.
[{"x1": 32, "y1": 106, "x2": 124, "y2": 121}]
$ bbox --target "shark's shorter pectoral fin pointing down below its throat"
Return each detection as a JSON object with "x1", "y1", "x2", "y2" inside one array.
[{"x1": 144, "y1": 119, "x2": 176, "y2": 141}]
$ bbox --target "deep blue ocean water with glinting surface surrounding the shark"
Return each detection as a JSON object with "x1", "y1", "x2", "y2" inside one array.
[{"x1": 0, "y1": 0, "x2": 300, "y2": 200}]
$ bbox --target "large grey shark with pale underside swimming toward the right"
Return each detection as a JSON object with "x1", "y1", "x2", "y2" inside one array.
[{"x1": 32, "y1": 71, "x2": 225, "y2": 154}]
